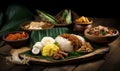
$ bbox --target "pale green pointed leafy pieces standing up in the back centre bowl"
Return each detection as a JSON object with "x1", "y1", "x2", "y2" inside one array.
[{"x1": 36, "y1": 9, "x2": 72, "y2": 25}]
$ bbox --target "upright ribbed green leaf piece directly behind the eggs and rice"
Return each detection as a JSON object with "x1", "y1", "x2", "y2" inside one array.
[{"x1": 30, "y1": 28, "x2": 70, "y2": 48}]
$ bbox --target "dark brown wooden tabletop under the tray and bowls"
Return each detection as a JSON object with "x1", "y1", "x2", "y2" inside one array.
[{"x1": 0, "y1": 18, "x2": 120, "y2": 71}]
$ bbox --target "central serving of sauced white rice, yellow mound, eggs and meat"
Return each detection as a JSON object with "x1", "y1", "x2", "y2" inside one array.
[{"x1": 32, "y1": 33, "x2": 94, "y2": 59}]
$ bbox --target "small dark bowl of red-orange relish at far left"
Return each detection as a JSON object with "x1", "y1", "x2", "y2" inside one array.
[{"x1": 2, "y1": 31, "x2": 29, "y2": 48}]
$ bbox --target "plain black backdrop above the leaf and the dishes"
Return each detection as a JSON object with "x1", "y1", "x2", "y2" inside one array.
[{"x1": 0, "y1": 0, "x2": 120, "y2": 18}]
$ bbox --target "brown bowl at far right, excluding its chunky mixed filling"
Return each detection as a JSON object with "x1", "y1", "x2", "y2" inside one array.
[{"x1": 84, "y1": 28, "x2": 119, "y2": 45}]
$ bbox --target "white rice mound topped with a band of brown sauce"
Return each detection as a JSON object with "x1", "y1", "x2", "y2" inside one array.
[{"x1": 55, "y1": 33, "x2": 85, "y2": 52}]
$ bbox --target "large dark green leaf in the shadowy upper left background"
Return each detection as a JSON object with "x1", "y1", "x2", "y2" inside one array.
[{"x1": 0, "y1": 5, "x2": 34, "y2": 37}]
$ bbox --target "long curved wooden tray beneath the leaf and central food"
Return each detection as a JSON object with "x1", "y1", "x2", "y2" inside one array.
[{"x1": 17, "y1": 47, "x2": 109, "y2": 65}]
